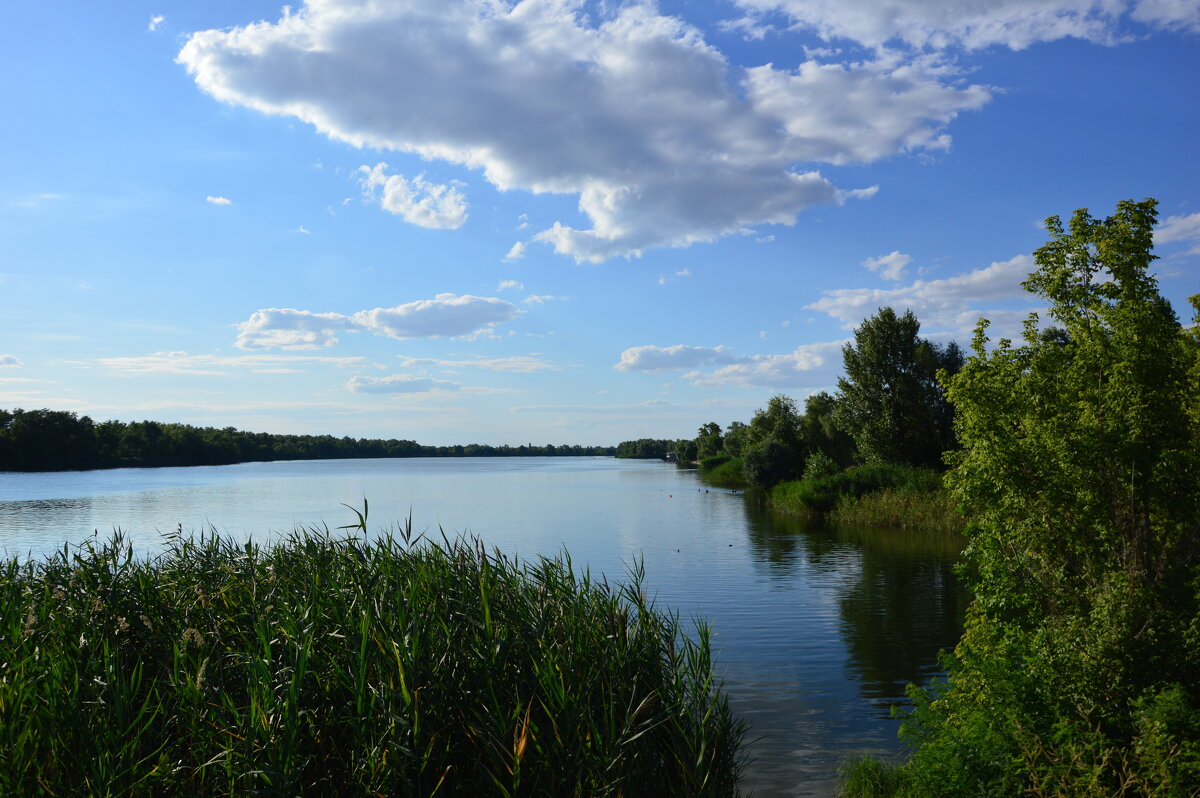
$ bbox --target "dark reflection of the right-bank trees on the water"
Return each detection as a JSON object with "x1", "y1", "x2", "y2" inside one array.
[{"x1": 745, "y1": 497, "x2": 968, "y2": 715}]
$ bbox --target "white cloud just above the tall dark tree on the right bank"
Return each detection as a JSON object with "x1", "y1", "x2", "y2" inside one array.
[{"x1": 804, "y1": 254, "x2": 1034, "y2": 331}]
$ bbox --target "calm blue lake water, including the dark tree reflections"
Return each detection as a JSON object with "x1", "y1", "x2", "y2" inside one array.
[{"x1": 0, "y1": 457, "x2": 964, "y2": 796}]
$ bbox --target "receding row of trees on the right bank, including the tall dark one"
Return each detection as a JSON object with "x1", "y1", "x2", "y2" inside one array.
[{"x1": 617, "y1": 307, "x2": 962, "y2": 487}]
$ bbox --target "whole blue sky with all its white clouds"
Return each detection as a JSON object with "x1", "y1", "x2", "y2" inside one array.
[{"x1": 0, "y1": 0, "x2": 1200, "y2": 445}]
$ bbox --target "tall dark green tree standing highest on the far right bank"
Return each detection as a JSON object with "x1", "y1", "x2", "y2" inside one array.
[{"x1": 834, "y1": 307, "x2": 962, "y2": 467}]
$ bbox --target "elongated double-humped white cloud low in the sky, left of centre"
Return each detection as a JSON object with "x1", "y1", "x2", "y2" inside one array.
[{"x1": 236, "y1": 294, "x2": 522, "y2": 349}]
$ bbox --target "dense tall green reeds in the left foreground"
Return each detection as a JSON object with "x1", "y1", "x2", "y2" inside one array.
[{"x1": 0, "y1": 517, "x2": 744, "y2": 796}]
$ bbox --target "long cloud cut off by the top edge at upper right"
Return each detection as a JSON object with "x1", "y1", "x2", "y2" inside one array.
[{"x1": 734, "y1": 0, "x2": 1200, "y2": 50}]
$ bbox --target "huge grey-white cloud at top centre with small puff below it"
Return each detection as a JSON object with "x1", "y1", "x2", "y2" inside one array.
[{"x1": 178, "y1": 0, "x2": 990, "y2": 262}]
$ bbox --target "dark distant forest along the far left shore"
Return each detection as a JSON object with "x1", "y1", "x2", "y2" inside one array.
[{"x1": 0, "y1": 409, "x2": 617, "y2": 472}]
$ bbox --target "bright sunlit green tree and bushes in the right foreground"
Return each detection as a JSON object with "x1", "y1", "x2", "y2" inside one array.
[{"x1": 905, "y1": 200, "x2": 1200, "y2": 796}]
